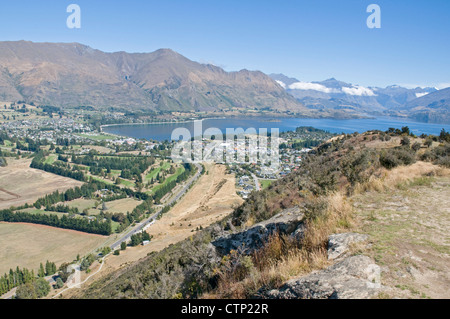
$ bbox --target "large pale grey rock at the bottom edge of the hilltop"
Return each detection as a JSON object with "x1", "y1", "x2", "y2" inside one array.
[{"x1": 264, "y1": 255, "x2": 381, "y2": 299}]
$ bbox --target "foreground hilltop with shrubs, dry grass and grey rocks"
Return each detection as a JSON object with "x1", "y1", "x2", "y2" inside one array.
[{"x1": 76, "y1": 128, "x2": 450, "y2": 298}]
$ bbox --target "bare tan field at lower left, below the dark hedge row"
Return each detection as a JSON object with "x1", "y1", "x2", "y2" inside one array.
[{"x1": 0, "y1": 223, "x2": 107, "y2": 275}]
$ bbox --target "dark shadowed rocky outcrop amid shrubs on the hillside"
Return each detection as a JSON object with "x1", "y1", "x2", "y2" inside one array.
[{"x1": 212, "y1": 207, "x2": 304, "y2": 255}]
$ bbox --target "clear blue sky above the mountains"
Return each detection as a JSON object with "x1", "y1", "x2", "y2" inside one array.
[{"x1": 0, "y1": 0, "x2": 450, "y2": 87}]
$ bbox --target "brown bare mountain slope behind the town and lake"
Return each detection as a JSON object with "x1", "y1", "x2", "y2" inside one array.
[{"x1": 0, "y1": 41, "x2": 310, "y2": 115}]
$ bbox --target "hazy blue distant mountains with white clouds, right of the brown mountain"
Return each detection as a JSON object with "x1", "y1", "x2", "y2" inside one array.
[{"x1": 270, "y1": 74, "x2": 450, "y2": 123}]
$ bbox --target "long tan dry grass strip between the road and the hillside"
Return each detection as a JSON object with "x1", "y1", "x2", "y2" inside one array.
[{"x1": 64, "y1": 164, "x2": 242, "y2": 298}]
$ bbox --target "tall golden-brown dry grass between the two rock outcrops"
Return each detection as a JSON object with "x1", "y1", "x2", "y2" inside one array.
[{"x1": 203, "y1": 192, "x2": 353, "y2": 299}]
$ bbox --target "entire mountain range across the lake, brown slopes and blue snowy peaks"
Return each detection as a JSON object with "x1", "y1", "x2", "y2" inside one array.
[{"x1": 0, "y1": 41, "x2": 450, "y2": 123}]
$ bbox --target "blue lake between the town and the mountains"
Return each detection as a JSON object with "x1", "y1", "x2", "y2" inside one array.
[{"x1": 103, "y1": 117, "x2": 450, "y2": 141}]
